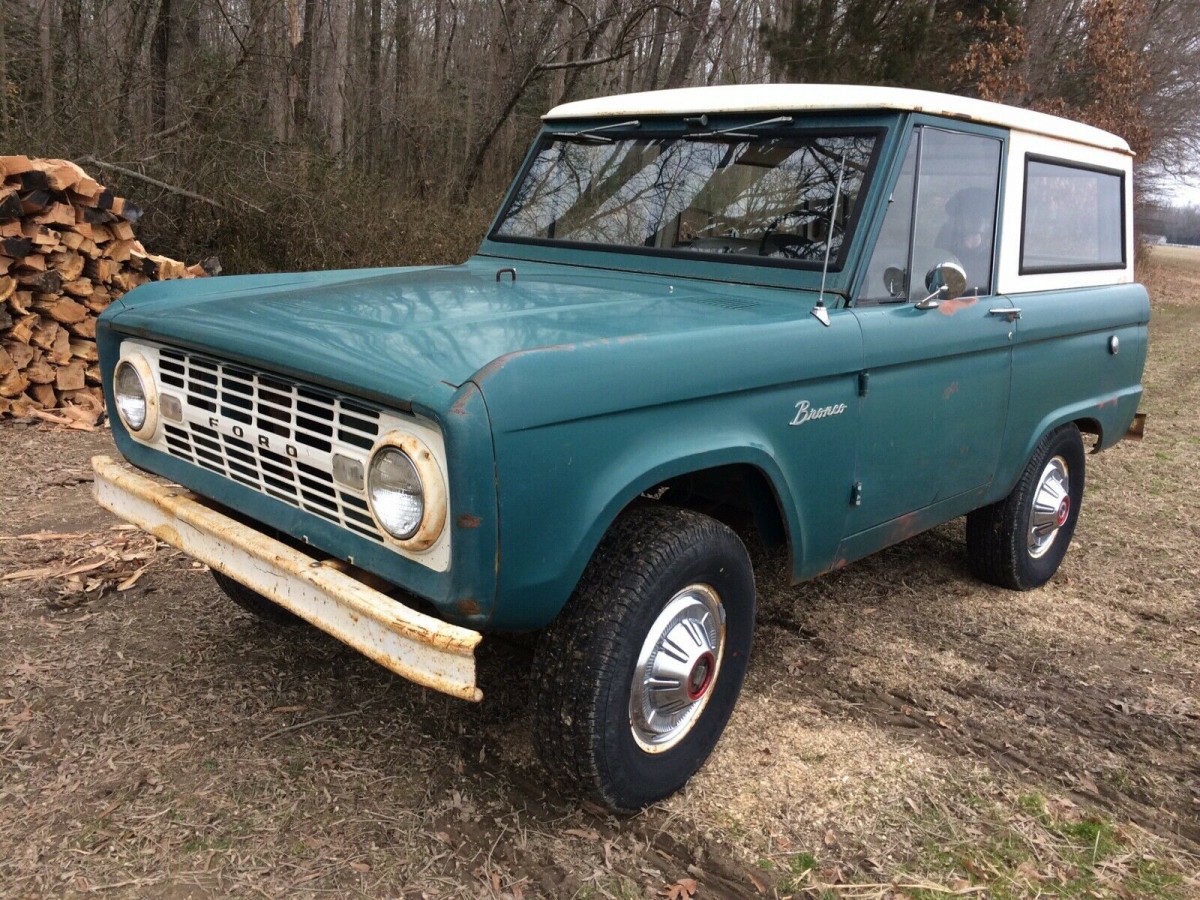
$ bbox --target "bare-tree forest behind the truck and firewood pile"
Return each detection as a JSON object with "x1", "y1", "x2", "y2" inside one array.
[{"x1": 0, "y1": 0, "x2": 1200, "y2": 272}]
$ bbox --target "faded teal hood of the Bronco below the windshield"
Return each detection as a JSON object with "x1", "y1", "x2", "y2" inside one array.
[{"x1": 107, "y1": 257, "x2": 812, "y2": 415}]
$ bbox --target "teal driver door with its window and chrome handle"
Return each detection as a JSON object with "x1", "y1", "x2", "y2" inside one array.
[{"x1": 847, "y1": 125, "x2": 1013, "y2": 544}]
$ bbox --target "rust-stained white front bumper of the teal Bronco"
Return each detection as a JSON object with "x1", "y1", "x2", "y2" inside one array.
[{"x1": 91, "y1": 456, "x2": 484, "y2": 701}]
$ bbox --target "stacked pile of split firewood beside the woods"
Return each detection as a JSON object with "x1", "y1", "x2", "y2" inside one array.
[{"x1": 0, "y1": 156, "x2": 217, "y2": 427}]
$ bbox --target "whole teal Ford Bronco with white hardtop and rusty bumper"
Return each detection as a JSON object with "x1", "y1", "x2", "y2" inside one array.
[{"x1": 95, "y1": 85, "x2": 1150, "y2": 810}]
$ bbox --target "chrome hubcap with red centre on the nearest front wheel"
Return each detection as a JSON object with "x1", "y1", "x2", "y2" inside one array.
[{"x1": 629, "y1": 584, "x2": 725, "y2": 754}]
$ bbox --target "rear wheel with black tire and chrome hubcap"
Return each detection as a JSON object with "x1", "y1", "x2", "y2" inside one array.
[{"x1": 967, "y1": 425, "x2": 1085, "y2": 590}]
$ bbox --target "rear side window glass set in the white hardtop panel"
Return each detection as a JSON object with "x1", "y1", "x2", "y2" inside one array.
[{"x1": 1021, "y1": 156, "x2": 1126, "y2": 275}]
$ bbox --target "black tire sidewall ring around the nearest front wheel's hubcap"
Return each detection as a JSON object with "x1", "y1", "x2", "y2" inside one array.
[{"x1": 595, "y1": 520, "x2": 755, "y2": 810}]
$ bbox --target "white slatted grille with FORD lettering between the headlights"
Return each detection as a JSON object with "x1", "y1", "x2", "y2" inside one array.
[{"x1": 158, "y1": 347, "x2": 390, "y2": 544}]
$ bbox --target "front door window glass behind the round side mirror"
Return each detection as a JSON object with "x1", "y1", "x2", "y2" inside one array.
[{"x1": 859, "y1": 126, "x2": 1001, "y2": 302}]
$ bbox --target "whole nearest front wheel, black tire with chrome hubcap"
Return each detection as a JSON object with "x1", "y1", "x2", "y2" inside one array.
[{"x1": 533, "y1": 505, "x2": 755, "y2": 812}]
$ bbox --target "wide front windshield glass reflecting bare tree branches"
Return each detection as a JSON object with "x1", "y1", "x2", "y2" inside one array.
[{"x1": 493, "y1": 132, "x2": 876, "y2": 268}]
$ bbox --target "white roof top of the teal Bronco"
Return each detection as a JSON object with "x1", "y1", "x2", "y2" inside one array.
[{"x1": 542, "y1": 84, "x2": 1133, "y2": 156}]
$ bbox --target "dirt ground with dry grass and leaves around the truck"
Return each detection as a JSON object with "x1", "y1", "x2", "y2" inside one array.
[{"x1": 0, "y1": 248, "x2": 1200, "y2": 900}]
